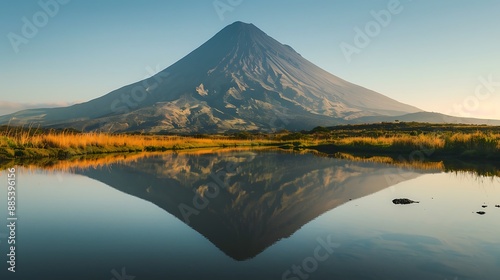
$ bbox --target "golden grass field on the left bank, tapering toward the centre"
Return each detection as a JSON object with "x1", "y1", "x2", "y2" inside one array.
[{"x1": 0, "y1": 127, "x2": 282, "y2": 158}]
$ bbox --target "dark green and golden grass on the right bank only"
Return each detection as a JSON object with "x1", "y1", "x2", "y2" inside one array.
[{"x1": 300, "y1": 123, "x2": 500, "y2": 160}]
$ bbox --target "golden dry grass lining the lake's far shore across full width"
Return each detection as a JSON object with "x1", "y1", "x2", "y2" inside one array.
[{"x1": 0, "y1": 125, "x2": 500, "y2": 158}]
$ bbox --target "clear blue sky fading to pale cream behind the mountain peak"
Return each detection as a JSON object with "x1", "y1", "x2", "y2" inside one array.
[{"x1": 0, "y1": 0, "x2": 500, "y2": 119}]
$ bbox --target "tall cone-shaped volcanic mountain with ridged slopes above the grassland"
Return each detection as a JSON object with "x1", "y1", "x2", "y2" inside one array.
[{"x1": 4, "y1": 22, "x2": 492, "y2": 133}]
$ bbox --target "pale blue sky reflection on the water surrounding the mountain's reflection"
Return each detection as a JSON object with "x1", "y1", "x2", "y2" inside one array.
[{"x1": 0, "y1": 160, "x2": 500, "y2": 280}]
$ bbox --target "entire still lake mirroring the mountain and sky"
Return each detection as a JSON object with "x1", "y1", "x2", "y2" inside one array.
[{"x1": 0, "y1": 150, "x2": 500, "y2": 280}]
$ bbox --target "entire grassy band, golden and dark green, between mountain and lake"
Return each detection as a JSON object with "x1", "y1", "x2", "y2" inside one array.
[{"x1": 0, "y1": 123, "x2": 500, "y2": 161}]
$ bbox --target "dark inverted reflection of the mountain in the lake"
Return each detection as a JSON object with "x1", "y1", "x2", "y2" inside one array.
[{"x1": 78, "y1": 151, "x2": 432, "y2": 260}]
